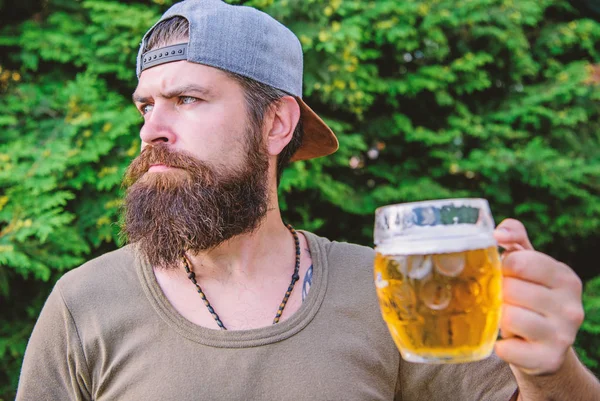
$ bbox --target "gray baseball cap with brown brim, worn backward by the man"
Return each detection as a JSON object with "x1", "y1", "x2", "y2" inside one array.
[{"x1": 136, "y1": 0, "x2": 339, "y2": 161}]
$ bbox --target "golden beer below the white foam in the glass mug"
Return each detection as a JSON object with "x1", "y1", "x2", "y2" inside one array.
[{"x1": 375, "y1": 246, "x2": 501, "y2": 362}]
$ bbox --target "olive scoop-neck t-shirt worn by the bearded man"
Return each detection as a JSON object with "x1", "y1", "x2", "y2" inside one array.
[{"x1": 17, "y1": 232, "x2": 516, "y2": 401}]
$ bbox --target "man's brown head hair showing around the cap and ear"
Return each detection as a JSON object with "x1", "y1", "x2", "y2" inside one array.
[{"x1": 143, "y1": 16, "x2": 304, "y2": 184}]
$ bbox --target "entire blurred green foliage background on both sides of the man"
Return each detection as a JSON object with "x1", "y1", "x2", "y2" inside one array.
[{"x1": 0, "y1": 0, "x2": 600, "y2": 400}]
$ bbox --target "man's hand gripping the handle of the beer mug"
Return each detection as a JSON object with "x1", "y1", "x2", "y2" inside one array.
[{"x1": 494, "y1": 219, "x2": 584, "y2": 376}]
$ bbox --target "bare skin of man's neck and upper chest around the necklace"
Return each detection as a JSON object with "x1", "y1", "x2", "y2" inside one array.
[{"x1": 154, "y1": 205, "x2": 312, "y2": 330}]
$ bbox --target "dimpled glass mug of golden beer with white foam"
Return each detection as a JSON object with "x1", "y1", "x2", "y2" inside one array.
[{"x1": 374, "y1": 199, "x2": 502, "y2": 363}]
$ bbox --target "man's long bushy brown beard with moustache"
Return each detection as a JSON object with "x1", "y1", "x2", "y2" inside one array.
[{"x1": 122, "y1": 130, "x2": 269, "y2": 269}]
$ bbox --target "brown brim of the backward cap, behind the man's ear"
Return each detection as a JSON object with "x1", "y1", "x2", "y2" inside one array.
[{"x1": 290, "y1": 97, "x2": 340, "y2": 162}]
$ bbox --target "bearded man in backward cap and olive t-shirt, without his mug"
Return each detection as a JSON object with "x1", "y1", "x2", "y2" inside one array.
[{"x1": 17, "y1": 0, "x2": 600, "y2": 401}]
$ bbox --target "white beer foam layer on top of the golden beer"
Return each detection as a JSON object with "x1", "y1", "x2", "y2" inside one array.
[{"x1": 375, "y1": 233, "x2": 498, "y2": 255}]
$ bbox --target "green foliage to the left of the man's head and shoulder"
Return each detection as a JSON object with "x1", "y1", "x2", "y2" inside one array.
[{"x1": 0, "y1": 1, "x2": 159, "y2": 398}]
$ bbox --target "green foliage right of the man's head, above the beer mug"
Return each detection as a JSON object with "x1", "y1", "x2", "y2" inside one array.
[{"x1": 264, "y1": 0, "x2": 600, "y2": 250}]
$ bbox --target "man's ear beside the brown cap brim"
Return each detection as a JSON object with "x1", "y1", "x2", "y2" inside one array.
[{"x1": 267, "y1": 96, "x2": 300, "y2": 156}]
